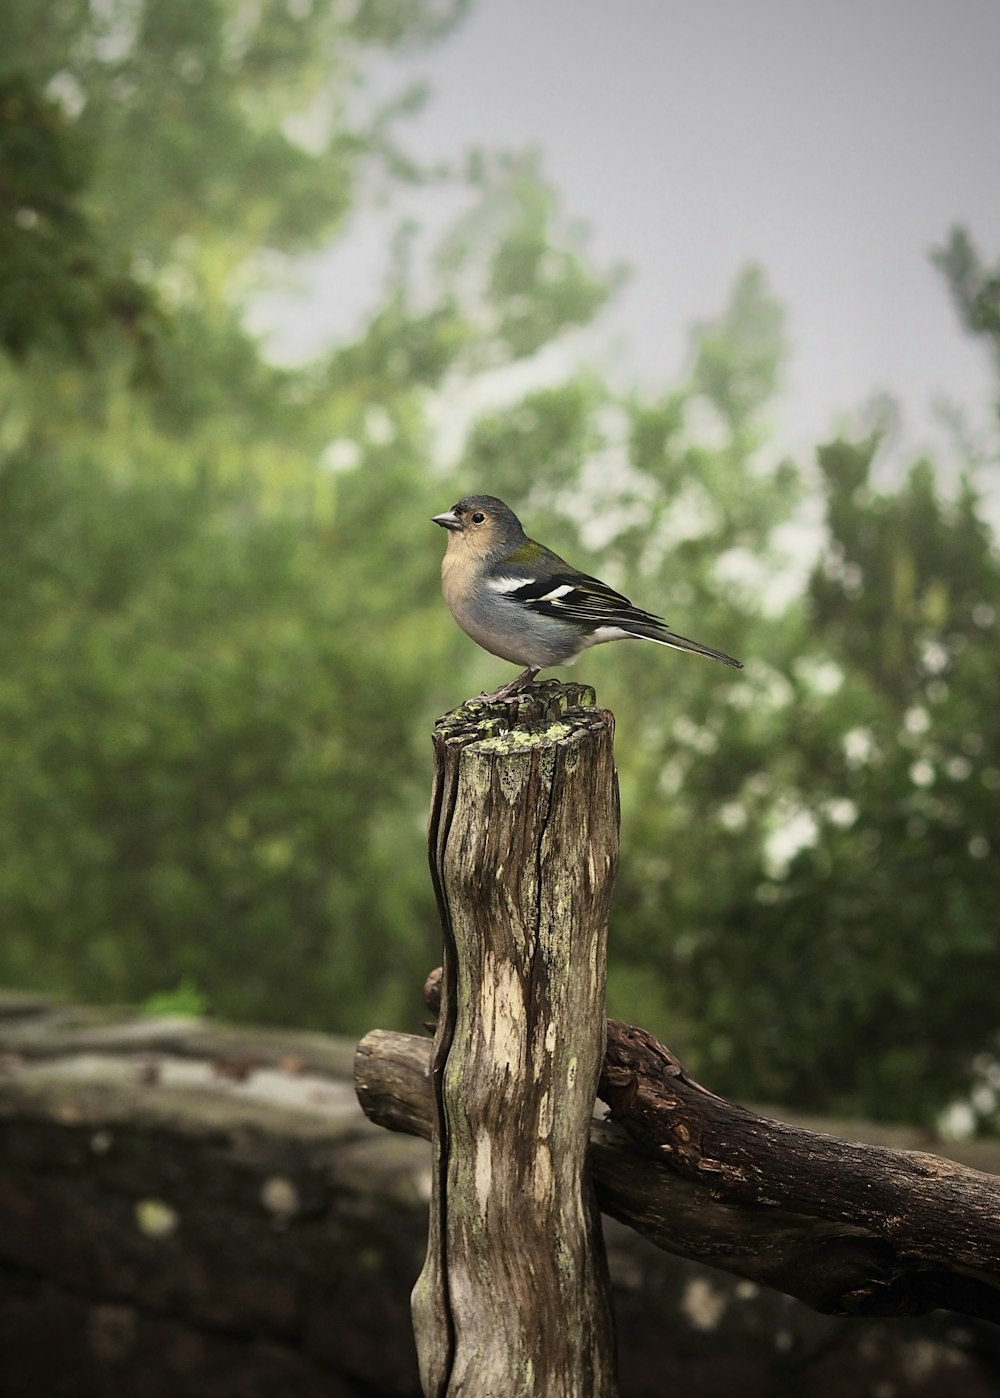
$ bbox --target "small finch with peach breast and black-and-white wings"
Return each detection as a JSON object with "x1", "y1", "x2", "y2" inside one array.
[{"x1": 432, "y1": 495, "x2": 743, "y2": 699}]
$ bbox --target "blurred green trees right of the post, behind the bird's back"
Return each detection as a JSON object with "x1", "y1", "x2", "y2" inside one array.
[{"x1": 466, "y1": 248, "x2": 1000, "y2": 1124}]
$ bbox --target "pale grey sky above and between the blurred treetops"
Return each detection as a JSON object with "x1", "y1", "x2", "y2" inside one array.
[{"x1": 255, "y1": 0, "x2": 1000, "y2": 475}]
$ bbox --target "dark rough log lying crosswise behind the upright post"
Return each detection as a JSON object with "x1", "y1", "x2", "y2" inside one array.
[{"x1": 355, "y1": 1021, "x2": 1000, "y2": 1321}]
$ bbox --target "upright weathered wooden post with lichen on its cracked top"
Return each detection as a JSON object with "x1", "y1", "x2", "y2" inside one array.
[{"x1": 413, "y1": 682, "x2": 618, "y2": 1398}]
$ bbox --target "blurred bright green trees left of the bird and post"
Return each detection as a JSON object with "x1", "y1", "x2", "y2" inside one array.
[{"x1": 0, "y1": 0, "x2": 626, "y2": 1028}]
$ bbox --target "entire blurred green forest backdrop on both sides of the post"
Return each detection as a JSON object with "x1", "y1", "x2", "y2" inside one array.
[{"x1": 0, "y1": 0, "x2": 1000, "y2": 1131}]
